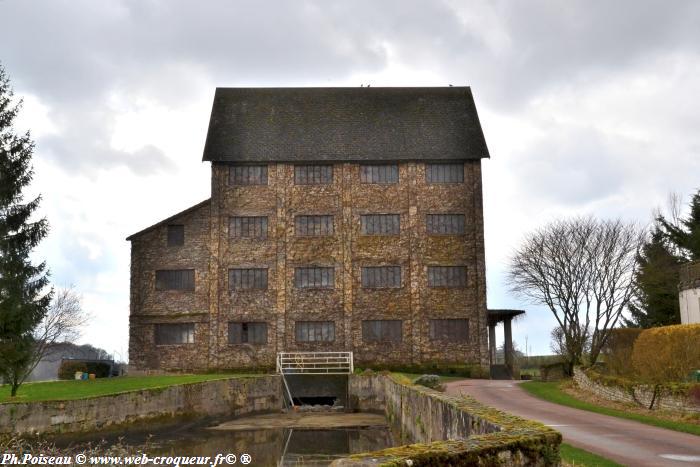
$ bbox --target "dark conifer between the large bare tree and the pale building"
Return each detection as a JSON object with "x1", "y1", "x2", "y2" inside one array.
[{"x1": 623, "y1": 224, "x2": 680, "y2": 328}]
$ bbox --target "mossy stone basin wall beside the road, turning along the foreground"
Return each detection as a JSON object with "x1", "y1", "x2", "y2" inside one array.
[{"x1": 340, "y1": 375, "x2": 561, "y2": 467}]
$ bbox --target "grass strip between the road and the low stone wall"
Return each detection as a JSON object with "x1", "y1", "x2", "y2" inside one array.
[{"x1": 520, "y1": 381, "x2": 700, "y2": 436}]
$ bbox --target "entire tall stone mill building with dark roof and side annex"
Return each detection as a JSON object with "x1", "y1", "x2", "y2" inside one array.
[{"x1": 128, "y1": 87, "x2": 489, "y2": 371}]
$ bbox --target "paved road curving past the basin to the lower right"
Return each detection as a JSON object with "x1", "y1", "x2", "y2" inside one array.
[{"x1": 447, "y1": 380, "x2": 700, "y2": 466}]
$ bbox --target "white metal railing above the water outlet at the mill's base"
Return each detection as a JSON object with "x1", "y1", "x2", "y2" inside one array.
[{"x1": 277, "y1": 352, "x2": 354, "y2": 375}]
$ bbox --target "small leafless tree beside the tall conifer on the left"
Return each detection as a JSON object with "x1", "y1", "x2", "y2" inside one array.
[{"x1": 21, "y1": 286, "x2": 90, "y2": 381}]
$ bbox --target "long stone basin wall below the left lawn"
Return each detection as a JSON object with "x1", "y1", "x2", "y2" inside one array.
[{"x1": 0, "y1": 376, "x2": 283, "y2": 435}]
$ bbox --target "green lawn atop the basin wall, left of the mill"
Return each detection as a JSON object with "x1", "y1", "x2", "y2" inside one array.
[{"x1": 0, "y1": 374, "x2": 250, "y2": 403}]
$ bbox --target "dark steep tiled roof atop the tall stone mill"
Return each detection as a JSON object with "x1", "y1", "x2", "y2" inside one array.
[{"x1": 203, "y1": 87, "x2": 489, "y2": 162}]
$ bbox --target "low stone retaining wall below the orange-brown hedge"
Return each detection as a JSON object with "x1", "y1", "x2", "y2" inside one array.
[{"x1": 574, "y1": 368, "x2": 700, "y2": 413}]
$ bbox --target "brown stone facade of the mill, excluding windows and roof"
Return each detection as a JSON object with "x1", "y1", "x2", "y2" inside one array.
[{"x1": 129, "y1": 160, "x2": 488, "y2": 371}]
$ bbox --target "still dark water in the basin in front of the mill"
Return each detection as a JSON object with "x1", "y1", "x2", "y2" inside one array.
[{"x1": 144, "y1": 428, "x2": 393, "y2": 466}]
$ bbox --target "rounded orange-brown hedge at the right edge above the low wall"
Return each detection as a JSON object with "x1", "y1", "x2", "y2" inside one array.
[{"x1": 632, "y1": 324, "x2": 700, "y2": 384}]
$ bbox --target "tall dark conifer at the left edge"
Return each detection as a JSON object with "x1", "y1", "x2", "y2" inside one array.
[{"x1": 0, "y1": 65, "x2": 52, "y2": 396}]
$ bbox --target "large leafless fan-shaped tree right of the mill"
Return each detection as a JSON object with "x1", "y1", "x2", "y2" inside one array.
[{"x1": 508, "y1": 217, "x2": 644, "y2": 370}]
